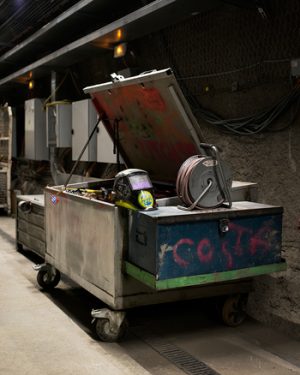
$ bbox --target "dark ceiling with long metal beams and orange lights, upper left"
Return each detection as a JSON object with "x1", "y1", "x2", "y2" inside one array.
[{"x1": 0, "y1": 0, "x2": 270, "y2": 103}]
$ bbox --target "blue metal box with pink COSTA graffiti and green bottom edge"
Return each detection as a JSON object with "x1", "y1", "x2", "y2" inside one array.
[{"x1": 127, "y1": 201, "x2": 282, "y2": 289}]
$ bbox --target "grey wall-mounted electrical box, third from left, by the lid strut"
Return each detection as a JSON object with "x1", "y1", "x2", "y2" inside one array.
[{"x1": 72, "y1": 99, "x2": 98, "y2": 161}]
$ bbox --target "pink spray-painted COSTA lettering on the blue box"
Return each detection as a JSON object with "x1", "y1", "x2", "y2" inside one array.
[{"x1": 172, "y1": 222, "x2": 272, "y2": 269}]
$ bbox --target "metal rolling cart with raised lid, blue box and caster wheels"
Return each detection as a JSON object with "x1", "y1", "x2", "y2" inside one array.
[{"x1": 37, "y1": 69, "x2": 285, "y2": 341}]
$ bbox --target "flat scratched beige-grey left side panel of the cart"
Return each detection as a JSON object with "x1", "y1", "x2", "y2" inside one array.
[{"x1": 45, "y1": 190, "x2": 115, "y2": 295}]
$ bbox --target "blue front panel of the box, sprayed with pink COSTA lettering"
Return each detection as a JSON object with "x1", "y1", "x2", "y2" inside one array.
[{"x1": 156, "y1": 215, "x2": 282, "y2": 280}]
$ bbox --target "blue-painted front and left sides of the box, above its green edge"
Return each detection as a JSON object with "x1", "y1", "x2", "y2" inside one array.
[{"x1": 128, "y1": 212, "x2": 282, "y2": 280}]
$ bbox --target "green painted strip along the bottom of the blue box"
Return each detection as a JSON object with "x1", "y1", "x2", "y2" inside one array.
[{"x1": 125, "y1": 261, "x2": 287, "y2": 290}]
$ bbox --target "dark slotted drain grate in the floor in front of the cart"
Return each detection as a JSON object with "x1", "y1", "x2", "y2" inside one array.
[{"x1": 134, "y1": 332, "x2": 220, "y2": 375}]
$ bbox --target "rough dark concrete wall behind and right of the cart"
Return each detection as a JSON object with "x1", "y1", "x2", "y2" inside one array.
[{"x1": 123, "y1": 0, "x2": 300, "y2": 337}]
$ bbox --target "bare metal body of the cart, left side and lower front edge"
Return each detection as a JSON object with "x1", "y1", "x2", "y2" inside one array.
[{"x1": 45, "y1": 185, "x2": 251, "y2": 309}]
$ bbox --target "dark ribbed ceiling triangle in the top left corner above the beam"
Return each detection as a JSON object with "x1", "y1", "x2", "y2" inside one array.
[{"x1": 0, "y1": 0, "x2": 79, "y2": 55}]
